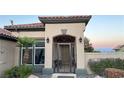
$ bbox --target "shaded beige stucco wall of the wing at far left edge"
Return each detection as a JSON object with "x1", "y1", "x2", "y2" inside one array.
[{"x1": 0, "y1": 40, "x2": 16, "y2": 76}]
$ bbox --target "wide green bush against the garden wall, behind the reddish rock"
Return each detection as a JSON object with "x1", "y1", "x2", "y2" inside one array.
[{"x1": 88, "y1": 59, "x2": 124, "y2": 76}]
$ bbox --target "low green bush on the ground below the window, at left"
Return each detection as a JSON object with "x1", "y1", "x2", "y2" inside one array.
[{"x1": 4, "y1": 65, "x2": 32, "y2": 78}]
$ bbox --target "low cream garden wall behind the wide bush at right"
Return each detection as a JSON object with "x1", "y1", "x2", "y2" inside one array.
[{"x1": 84, "y1": 52, "x2": 124, "y2": 73}]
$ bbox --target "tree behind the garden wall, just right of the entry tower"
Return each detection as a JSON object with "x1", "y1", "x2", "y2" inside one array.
[{"x1": 84, "y1": 37, "x2": 94, "y2": 52}]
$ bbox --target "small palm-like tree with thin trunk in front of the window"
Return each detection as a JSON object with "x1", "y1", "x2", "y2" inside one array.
[{"x1": 17, "y1": 37, "x2": 35, "y2": 64}]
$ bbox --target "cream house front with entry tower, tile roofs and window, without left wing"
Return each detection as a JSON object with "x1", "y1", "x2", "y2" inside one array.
[{"x1": 4, "y1": 16, "x2": 91, "y2": 74}]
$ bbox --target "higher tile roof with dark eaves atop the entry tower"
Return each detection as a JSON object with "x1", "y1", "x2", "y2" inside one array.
[{"x1": 38, "y1": 15, "x2": 92, "y2": 24}]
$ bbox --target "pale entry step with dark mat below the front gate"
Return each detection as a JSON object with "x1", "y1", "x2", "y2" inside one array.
[{"x1": 52, "y1": 73, "x2": 76, "y2": 78}]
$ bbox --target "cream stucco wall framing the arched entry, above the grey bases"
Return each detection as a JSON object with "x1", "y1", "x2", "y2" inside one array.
[{"x1": 45, "y1": 23, "x2": 85, "y2": 69}]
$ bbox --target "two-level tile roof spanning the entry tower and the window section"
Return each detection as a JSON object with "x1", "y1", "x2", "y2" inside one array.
[{"x1": 4, "y1": 15, "x2": 91, "y2": 31}]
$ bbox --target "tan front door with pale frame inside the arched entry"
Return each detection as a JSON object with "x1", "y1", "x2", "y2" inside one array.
[{"x1": 54, "y1": 43, "x2": 74, "y2": 73}]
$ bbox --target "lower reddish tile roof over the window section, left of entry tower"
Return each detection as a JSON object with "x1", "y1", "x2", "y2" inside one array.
[{"x1": 4, "y1": 23, "x2": 44, "y2": 29}]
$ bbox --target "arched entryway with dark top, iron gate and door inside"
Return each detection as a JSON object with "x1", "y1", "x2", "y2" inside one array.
[{"x1": 53, "y1": 35, "x2": 76, "y2": 73}]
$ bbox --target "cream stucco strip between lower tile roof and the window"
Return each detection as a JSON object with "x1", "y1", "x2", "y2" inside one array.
[{"x1": 12, "y1": 31, "x2": 45, "y2": 39}]
